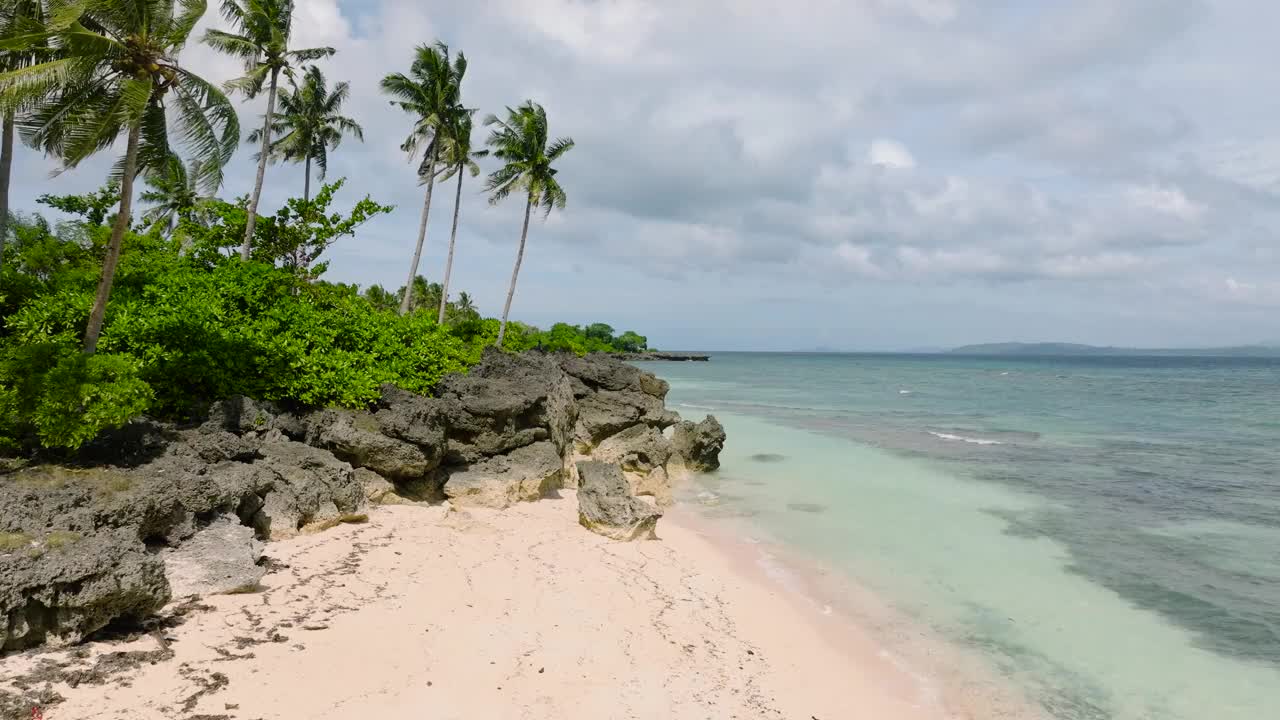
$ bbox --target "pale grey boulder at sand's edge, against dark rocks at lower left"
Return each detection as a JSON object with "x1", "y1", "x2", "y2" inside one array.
[{"x1": 163, "y1": 515, "x2": 266, "y2": 597}]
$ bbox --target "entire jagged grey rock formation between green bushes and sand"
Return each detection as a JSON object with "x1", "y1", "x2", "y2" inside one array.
[{"x1": 0, "y1": 350, "x2": 724, "y2": 651}]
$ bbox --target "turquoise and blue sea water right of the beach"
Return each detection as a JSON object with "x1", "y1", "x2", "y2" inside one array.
[{"x1": 650, "y1": 354, "x2": 1280, "y2": 720}]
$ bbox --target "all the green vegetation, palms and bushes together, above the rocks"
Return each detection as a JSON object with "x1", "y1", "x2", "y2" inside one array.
[{"x1": 0, "y1": 0, "x2": 648, "y2": 450}]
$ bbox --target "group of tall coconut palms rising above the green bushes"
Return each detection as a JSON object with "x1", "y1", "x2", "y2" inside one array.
[{"x1": 0, "y1": 0, "x2": 573, "y2": 354}]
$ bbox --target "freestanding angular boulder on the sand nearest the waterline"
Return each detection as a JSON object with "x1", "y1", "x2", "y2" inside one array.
[{"x1": 577, "y1": 460, "x2": 662, "y2": 541}]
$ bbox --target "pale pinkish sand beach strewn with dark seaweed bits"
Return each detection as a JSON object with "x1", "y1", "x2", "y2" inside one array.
[{"x1": 0, "y1": 492, "x2": 962, "y2": 720}]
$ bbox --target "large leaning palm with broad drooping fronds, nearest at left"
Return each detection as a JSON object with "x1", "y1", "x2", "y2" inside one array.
[{"x1": 0, "y1": 0, "x2": 239, "y2": 354}]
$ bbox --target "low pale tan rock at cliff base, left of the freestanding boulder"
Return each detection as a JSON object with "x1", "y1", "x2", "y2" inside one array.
[{"x1": 444, "y1": 441, "x2": 564, "y2": 507}]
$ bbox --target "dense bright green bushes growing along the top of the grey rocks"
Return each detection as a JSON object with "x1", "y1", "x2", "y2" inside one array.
[{"x1": 0, "y1": 181, "x2": 645, "y2": 448}]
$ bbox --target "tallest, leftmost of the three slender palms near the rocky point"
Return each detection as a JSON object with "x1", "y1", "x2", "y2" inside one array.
[{"x1": 381, "y1": 42, "x2": 467, "y2": 315}]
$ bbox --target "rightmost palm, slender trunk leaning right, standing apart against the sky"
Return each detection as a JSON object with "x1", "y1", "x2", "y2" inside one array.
[{"x1": 484, "y1": 100, "x2": 573, "y2": 347}]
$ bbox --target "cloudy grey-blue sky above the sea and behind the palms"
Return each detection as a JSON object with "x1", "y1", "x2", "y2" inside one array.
[{"x1": 12, "y1": 0, "x2": 1280, "y2": 350}]
